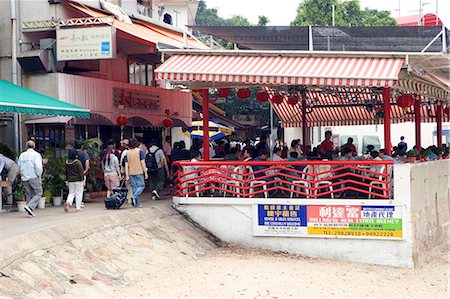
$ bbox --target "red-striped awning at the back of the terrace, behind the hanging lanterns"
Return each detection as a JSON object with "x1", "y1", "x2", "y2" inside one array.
[{"x1": 269, "y1": 88, "x2": 450, "y2": 127}]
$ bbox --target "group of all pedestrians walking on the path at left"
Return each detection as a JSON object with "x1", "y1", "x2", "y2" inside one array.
[{"x1": 0, "y1": 138, "x2": 170, "y2": 217}]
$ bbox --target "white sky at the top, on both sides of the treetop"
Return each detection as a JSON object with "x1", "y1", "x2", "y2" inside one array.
[{"x1": 205, "y1": 0, "x2": 450, "y2": 27}]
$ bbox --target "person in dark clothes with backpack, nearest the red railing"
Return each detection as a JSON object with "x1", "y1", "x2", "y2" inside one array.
[{"x1": 145, "y1": 139, "x2": 169, "y2": 200}]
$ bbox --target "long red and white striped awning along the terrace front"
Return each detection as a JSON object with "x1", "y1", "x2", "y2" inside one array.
[{"x1": 155, "y1": 54, "x2": 403, "y2": 87}]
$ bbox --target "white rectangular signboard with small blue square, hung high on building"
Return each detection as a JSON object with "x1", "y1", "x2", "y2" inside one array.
[{"x1": 56, "y1": 26, "x2": 116, "y2": 61}]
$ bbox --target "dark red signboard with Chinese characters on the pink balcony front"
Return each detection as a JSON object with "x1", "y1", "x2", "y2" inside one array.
[{"x1": 113, "y1": 87, "x2": 161, "y2": 110}]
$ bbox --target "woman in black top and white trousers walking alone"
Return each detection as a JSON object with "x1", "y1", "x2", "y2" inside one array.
[{"x1": 64, "y1": 149, "x2": 84, "y2": 212}]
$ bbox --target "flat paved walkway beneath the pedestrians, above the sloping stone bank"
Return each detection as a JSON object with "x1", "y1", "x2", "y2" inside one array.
[{"x1": 0, "y1": 192, "x2": 172, "y2": 240}]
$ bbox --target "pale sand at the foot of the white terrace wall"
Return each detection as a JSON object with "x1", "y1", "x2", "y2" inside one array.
[{"x1": 113, "y1": 247, "x2": 450, "y2": 298}]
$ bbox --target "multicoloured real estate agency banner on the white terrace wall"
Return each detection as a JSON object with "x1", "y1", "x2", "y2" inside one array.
[{"x1": 254, "y1": 204, "x2": 403, "y2": 239}]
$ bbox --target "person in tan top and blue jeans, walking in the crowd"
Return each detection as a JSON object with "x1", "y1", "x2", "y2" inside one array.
[{"x1": 125, "y1": 138, "x2": 148, "y2": 208}]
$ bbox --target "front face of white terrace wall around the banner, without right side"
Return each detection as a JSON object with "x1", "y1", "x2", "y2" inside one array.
[{"x1": 175, "y1": 198, "x2": 413, "y2": 267}]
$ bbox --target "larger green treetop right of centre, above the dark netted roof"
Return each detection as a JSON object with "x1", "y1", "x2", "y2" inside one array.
[{"x1": 291, "y1": 0, "x2": 397, "y2": 26}]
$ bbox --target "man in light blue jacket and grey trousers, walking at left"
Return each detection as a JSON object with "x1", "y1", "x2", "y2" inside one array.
[{"x1": 17, "y1": 140, "x2": 43, "y2": 217}]
